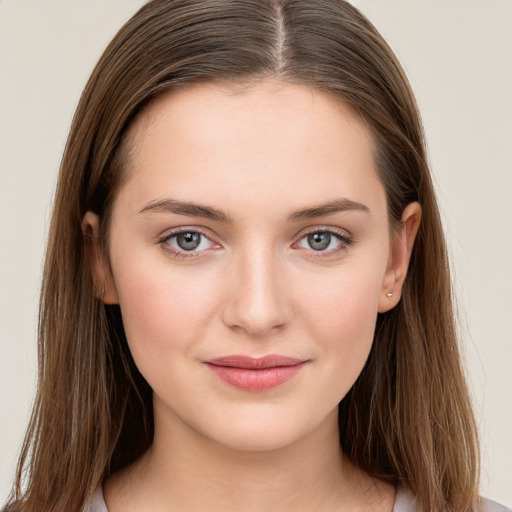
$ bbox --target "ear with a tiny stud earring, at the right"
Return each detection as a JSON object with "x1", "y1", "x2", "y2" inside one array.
[{"x1": 378, "y1": 202, "x2": 421, "y2": 313}]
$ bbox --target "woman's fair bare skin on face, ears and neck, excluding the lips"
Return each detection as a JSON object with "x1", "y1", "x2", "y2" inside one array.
[{"x1": 82, "y1": 80, "x2": 421, "y2": 512}]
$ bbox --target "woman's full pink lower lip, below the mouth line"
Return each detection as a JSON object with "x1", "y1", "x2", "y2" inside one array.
[{"x1": 207, "y1": 363, "x2": 304, "y2": 391}]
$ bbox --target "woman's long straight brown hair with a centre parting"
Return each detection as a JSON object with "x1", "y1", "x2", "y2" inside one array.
[{"x1": 5, "y1": 0, "x2": 479, "y2": 512}]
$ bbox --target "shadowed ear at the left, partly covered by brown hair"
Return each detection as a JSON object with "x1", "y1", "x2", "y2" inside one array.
[{"x1": 81, "y1": 211, "x2": 118, "y2": 304}]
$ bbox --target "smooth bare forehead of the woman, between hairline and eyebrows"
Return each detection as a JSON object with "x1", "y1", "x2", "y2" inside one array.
[{"x1": 114, "y1": 80, "x2": 379, "y2": 216}]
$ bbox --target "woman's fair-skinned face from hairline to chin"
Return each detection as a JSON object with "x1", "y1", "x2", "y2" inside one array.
[{"x1": 84, "y1": 81, "x2": 420, "y2": 450}]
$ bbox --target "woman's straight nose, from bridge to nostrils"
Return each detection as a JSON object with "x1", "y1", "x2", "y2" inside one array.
[{"x1": 222, "y1": 244, "x2": 291, "y2": 337}]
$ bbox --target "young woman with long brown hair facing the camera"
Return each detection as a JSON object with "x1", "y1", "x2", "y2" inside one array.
[{"x1": 3, "y1": 0, "x2": 508, "y2": 512}]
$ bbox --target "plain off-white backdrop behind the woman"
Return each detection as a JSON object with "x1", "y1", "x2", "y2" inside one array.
[{"x1": 0, "y1": 0, "x2": 512, "y2": 506}]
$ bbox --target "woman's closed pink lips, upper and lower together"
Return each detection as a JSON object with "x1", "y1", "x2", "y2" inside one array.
[{"x1": 204, "y1": 354, "x2": 307, "y2": 391}]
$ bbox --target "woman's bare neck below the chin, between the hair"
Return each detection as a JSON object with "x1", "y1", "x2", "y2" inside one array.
[{"x1": 105, "y1": 410, "x2": 394, "y2": 512}]
